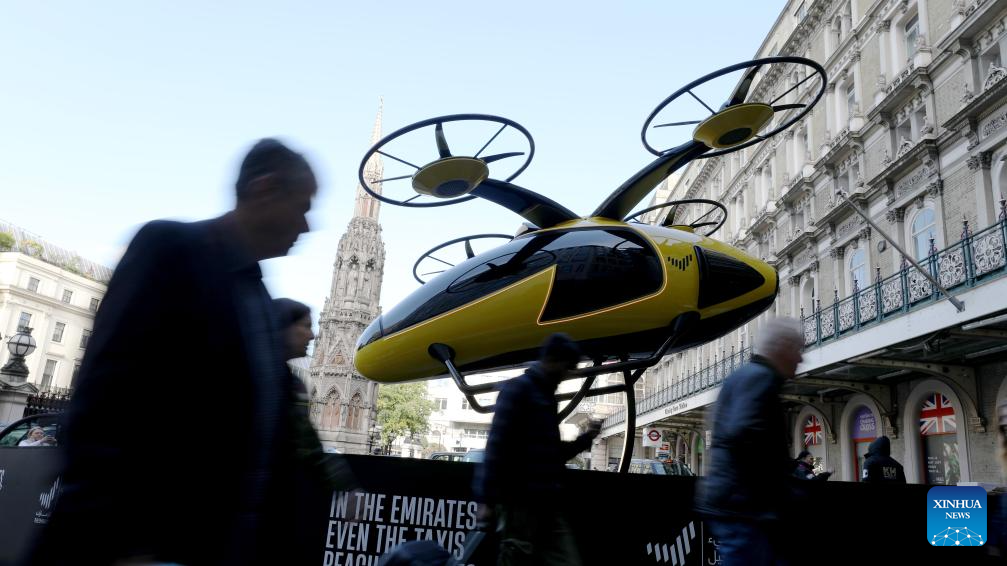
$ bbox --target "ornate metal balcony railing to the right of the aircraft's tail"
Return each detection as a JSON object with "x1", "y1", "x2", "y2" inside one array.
[{"x1": 802, "y1": 215, "x2": 1007, "y2": 347}]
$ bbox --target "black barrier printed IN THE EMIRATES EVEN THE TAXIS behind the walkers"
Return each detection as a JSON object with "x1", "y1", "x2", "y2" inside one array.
[{"x1": 0, "y1": 448, "x2": 990, "y2": 566}]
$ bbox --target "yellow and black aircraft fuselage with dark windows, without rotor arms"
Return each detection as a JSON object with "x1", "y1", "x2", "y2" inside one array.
[{"x1": 355, "y1": 218, "x2": 778, "y2": 382}]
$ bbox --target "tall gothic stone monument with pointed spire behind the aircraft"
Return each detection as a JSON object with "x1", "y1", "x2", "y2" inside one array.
[{"x1": 308, "y1": 104, "x2": 385, "y2": 454}]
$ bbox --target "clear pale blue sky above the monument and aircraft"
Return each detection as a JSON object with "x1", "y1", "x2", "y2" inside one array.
[{"x1": 0, "y1": 0, "x2": 783, "y2": 315}]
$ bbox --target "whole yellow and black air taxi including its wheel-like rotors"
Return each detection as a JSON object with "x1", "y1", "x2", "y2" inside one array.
[{"x1": 354, "y1": 56, "x2": 826, "y2": 382}]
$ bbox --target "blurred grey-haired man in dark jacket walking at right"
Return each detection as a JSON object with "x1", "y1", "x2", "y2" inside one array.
[{"x1": 696, "y1": 318, "x2": 804, "y2": 566}]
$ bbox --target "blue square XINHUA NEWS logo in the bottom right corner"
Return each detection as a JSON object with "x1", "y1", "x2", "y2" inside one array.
[{"x1": 926, "y1": 485, "x2": 987, "y2": 546}]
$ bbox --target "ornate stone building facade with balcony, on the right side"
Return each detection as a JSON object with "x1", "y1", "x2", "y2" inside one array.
[{"x1": 601, "y1": 0, "x2": 1007, "y2": 483}]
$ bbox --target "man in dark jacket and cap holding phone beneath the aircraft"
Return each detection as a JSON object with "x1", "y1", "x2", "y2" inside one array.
[{"x1": 474, "y1": 334, "x2": 600, "y2": 566}]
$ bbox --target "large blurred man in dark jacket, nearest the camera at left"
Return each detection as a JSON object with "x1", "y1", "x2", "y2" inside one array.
[{"x1": 31, "y1": 139, "x2": 317, "y2": 566}]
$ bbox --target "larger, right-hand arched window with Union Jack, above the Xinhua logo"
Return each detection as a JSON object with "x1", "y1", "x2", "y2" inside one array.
[{"x1": 918, "y1": 392, "x2": 962, "y2": 485}]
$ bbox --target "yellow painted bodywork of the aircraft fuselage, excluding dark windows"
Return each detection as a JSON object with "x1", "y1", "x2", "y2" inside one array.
[{"x1": 354, "y1": 219, "x2": 775, "y2": 382}]
